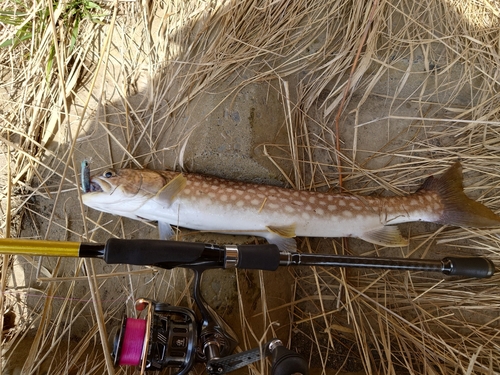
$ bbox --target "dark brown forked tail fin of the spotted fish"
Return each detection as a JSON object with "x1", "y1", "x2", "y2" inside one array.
[{"x1": 419, "y1": 162, "x2": 500, "y2": 228}]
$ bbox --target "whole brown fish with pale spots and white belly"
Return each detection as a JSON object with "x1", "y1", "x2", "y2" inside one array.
[{"x1": 82, "y1": 162, "x2": 500, "y2": 251}]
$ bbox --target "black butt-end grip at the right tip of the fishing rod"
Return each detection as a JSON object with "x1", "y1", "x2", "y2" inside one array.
[{"x1": 442, "y1": 257, "x2": 495, "y2": 279}]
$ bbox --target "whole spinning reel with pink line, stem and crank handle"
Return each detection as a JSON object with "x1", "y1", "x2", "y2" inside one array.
[{"x1": 112, "y1": 270, "x2": 309, "y2": 375}]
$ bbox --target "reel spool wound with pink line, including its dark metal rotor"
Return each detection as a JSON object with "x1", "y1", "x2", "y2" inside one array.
[{"x1": 112, "y1": 298, "x2": 198, "y2": 375}]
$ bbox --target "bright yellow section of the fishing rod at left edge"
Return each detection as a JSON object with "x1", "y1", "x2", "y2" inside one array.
[{"x1": 0, "y1": 238, "x2": 80, "y2": 257}]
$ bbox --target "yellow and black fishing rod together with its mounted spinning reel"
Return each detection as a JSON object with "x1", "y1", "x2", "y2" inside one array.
[{"x1": 0, "y1": 238, "x2": 495, "y2": 375}]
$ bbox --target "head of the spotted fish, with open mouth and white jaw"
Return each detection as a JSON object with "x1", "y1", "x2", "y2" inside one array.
[{"x1": 82, "y1": 169, "x2": 165, "y2": 219}]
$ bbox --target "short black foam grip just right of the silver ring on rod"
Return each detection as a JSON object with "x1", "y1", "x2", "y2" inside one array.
[{"x1": 236, "y1": 244, "x2": 280, "y2": 271}]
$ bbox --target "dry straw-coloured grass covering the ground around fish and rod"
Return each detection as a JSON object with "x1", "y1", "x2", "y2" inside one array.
[{"x1": 0, "y1": 0, "x2": 500, "y2": 374}]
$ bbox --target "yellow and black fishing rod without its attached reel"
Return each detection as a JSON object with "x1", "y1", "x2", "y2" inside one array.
[{"x1": 0, "y1": 238, "x2": 495, "y2": 278}]
